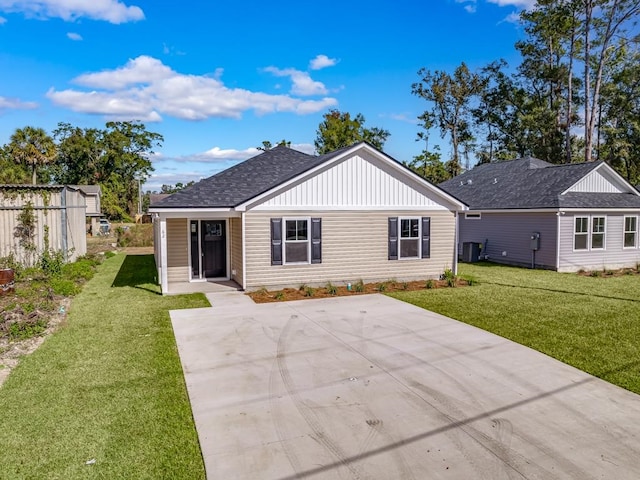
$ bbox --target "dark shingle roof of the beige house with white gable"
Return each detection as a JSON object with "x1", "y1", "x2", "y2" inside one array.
[{"x1": 151, "y1": 146, "x2": 362, "y2": 208}]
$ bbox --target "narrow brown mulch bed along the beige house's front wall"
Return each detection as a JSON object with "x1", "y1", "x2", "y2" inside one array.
[{"x1": 247, "y1": 278, "x2": 473, "y2": 303}]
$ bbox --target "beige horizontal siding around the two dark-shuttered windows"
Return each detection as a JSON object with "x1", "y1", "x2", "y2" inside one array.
[{"x1": 245, "y1": 210, "x2": 455, "y2": 290}]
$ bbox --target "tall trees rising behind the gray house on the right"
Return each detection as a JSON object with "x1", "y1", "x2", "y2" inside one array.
[{"x1": 408, "y1": 0, "x2": 640, "y2": 184}]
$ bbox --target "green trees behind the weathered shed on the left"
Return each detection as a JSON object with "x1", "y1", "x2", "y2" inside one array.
[{"x1": 0, "y1": 122, "x2": 163, "y2": 220}]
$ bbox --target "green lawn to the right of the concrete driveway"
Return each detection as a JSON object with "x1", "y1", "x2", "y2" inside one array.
[{"x1": 390, "y1": 263, "x2": 640, "y2": 393}]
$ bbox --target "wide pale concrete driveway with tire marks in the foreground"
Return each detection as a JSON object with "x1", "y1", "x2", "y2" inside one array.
[{"x1": 171, "y1": 292, "x2": 640, "y2": 480}]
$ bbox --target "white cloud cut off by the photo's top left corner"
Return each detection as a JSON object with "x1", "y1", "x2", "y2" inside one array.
[{"x1": 0, "y1": 0, "x2": 144, "y2": 24}]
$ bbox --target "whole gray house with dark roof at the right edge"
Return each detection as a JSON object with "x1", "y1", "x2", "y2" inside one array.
[{"x1": 439, "y1": 158, "x2": 640, "y2": 272}]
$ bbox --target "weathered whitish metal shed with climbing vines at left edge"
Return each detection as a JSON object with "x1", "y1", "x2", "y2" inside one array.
[{"x1": 0, "y1": 185, "x2": 87, "y2": 264}]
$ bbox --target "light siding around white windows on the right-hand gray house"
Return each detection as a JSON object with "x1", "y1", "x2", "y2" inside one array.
[{"x1": 558, "y1": 211, "x2": 640, "y2": 272}]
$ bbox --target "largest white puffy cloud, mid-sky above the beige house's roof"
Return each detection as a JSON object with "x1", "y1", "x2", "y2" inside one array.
[{"x1": 48, "y1": 55, "x2": 338, "y2": 122}]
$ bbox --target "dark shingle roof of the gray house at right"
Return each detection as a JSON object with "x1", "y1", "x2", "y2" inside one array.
[{"x1": 438, "y1": 158, "x2": 640, "y2": 210}]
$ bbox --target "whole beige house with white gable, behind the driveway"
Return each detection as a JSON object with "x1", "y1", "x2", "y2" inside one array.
[{"x1": 149, "y1": 143, "x2": 466, "y2": 293}]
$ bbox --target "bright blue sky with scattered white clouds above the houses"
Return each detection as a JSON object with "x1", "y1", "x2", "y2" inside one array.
[{"x1": 0, "y1": 0, "x2": 534, "y2": 190}]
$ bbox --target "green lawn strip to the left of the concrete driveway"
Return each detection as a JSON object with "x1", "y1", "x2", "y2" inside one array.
[{"x1": 0, "y1": 255, "x2": 209, "y2": 480}]
